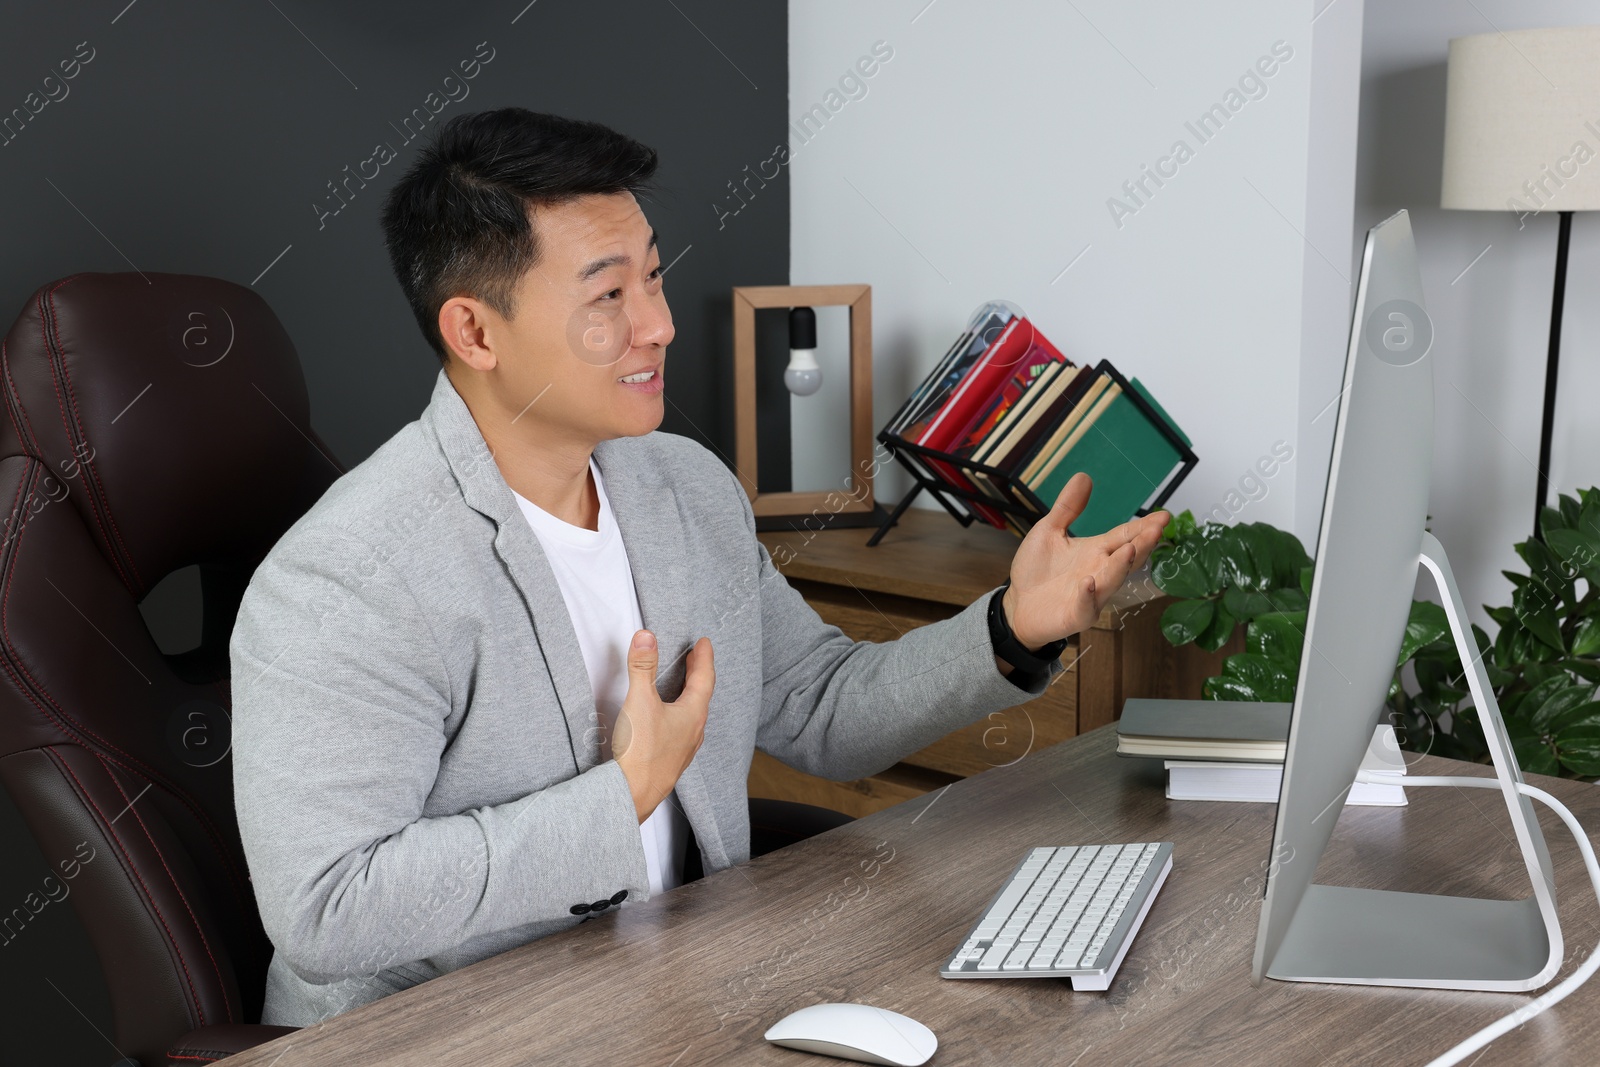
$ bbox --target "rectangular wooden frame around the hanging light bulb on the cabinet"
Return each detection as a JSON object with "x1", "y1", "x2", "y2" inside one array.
[{"x1": 733, "y1": 285, "x2": 877, "y2": 518}]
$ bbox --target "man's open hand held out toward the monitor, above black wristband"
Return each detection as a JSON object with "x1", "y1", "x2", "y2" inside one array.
[{"x1": 1002, "y1": 472, "x2": 1168, "y2": 649}]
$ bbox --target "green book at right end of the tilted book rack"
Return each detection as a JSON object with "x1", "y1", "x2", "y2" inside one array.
[{"x1": 1032, "y1": 389, "x2": 1181, "y2": 537}]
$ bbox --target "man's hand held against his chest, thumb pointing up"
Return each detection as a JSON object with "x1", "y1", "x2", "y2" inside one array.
[{"x1": 611, "y1": 630, "x2": 717, "y2": 822}]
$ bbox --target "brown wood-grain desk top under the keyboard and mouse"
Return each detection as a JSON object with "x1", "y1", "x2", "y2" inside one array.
[{"x1": 229, "y1": 728, "x2": 1600, "y2": 1067}]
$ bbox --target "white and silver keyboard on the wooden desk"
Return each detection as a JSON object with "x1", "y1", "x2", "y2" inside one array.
[{"x1": 939, "y1": 841, "x2": 1173, "y2": 989}]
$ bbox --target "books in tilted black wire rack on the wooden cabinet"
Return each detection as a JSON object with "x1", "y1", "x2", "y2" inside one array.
[{"x1": 872, "y1": 302, "x2": 1197, "y2": 544}]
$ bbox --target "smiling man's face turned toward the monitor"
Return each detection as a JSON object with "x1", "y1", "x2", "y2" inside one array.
[{"x1": 454, "y1": 192, "x2": 674, "y2": 445}]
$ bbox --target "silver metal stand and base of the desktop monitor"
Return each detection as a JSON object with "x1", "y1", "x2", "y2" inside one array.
[{"x1": 1267, "y1": 531, "x2": 1562, "y2": 992}]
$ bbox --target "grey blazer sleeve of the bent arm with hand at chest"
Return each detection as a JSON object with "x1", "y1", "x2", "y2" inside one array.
[{"x1": 229, "y1": 530, "x2": 650, "y2": 981}]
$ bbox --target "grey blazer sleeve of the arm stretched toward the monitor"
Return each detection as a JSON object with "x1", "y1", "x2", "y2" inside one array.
[{"x1": 728, "y1": 463, "x2": 1066, "y2": 781}]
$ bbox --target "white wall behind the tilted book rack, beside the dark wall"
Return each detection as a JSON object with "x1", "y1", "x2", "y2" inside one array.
[{"x1": 789, "y1": 0, "x2": 1362, "y2": 544}]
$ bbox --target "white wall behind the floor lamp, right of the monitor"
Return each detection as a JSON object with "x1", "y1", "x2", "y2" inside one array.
[{"x1": 1354, "y1": 0, "x2": 1600, "y2": 633}]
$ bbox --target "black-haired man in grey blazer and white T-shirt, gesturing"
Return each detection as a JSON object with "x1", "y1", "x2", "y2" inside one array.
[{"x1": 230, "y1": 109, "x2": 1166, "y2": 1025}]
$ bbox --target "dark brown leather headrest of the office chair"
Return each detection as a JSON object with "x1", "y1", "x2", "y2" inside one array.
[{"x1": 0, "y1": 272, "x2": 341, "y2": 598}]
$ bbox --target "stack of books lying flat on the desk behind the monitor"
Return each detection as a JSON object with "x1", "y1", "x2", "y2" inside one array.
[{"x1": 1117, "y1": 699, "x2": 1406, "y2": 808}]
